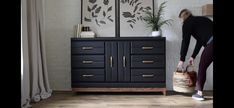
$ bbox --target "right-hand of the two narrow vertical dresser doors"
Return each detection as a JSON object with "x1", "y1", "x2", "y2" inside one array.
[{"x1": 118, "y1": 42, "x2": 130, "y2": 82}]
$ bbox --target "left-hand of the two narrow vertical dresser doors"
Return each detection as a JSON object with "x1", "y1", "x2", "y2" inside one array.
[{"x1": 105, "y1": 42, "x2": 118, "y2": 82}]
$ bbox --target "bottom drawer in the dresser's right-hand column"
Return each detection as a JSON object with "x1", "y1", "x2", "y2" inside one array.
[{"x1": 131, "y1": 69, "x2": 165, "y2": 82}]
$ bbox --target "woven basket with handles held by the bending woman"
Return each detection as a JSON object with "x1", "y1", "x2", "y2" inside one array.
[{"x1": 173, "y1": 65, "x2": 197, "y2": 93}]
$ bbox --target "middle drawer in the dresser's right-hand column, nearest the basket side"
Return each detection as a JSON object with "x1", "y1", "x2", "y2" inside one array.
[{"x1": 131, "y1": 55, "x2": 165, "y2": 68}]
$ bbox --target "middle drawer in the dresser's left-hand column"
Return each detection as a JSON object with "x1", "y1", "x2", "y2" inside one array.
[{"x1": 71, "y1": 55, "x2": 104, "y2": 68}]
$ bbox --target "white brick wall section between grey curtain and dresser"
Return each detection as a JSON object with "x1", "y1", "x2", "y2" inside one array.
[{"x1": 45, "y1": 0, "x2": 81, "y2": 90}]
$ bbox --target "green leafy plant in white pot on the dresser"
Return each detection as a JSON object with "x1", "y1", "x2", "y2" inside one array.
[{"x1": 143, "y1": 2, "x2": 172, "y2": 36}]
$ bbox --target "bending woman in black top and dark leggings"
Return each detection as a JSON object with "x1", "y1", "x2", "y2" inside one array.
[{"x1": 177, "y1": 9, "x2": 213, "y2": 100}]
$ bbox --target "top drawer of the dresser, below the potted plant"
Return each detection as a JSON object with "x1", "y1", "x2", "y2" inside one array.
[{"x1": 131, "y1": 41, "x2": 165, "y2": 54}]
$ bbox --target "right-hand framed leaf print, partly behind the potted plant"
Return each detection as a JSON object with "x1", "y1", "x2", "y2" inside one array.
[{"x1": 119, "y1": 0, "x2": 154, "y2": 37}]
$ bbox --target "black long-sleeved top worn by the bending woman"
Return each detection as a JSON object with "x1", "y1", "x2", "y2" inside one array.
[{"x1": 180, "y1": 15, "x2": 213, "y2": 61}]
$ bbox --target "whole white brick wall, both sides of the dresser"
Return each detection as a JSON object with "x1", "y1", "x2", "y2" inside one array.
[{"x1": 45, "y1": 0, "x2": 213, "y2": 90}]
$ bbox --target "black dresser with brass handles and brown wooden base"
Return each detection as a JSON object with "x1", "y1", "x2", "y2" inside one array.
[{"x1": 71, "y1": 37, "x2": 166, "y2": 95}]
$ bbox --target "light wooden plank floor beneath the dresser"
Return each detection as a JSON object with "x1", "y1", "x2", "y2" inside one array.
[{"x1": 32, "y1": 92, "x2": 213, "y2": 108}]
